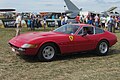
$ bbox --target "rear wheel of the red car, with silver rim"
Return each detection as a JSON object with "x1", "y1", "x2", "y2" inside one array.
[{"x1": 96, "y1": 40, "x2": 109, "y2": 56}]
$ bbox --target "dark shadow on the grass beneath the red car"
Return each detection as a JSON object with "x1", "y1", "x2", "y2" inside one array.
[{"x1": 19, "y1": 49, "x2": 120, "y2": 63}]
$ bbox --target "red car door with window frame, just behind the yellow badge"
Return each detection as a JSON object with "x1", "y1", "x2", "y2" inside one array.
[{"x1": 74, "y1": 26, "x2": 96, "y2": 51}]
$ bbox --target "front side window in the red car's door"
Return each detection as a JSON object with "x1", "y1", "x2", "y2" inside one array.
[{"x1": 78, "y1": 26, "x2": 94, "y2": 35}]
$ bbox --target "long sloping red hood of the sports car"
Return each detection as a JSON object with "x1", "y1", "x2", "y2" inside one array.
[{"x1": 9, "y1": 31, "x2": 61, "y2": 47}]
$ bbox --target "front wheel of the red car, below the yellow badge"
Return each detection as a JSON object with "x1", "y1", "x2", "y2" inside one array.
[{"x1": 37, "y1": 43, "x2": 57, "y2": 61}]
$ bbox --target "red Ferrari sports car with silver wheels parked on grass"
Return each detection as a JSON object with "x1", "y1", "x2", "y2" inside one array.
[{"x1": 9, "y1": 24, "x2": 117, "y2": 61}]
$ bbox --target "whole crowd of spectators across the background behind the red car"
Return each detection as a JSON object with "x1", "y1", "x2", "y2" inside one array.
[{"x1": 15, "y1": 14, "x2": 120, "y2": 36}]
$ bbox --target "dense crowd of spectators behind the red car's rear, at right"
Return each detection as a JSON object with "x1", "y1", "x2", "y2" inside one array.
[{"x1": 75, "y1": 14, "x2": 120, "y2": 32}]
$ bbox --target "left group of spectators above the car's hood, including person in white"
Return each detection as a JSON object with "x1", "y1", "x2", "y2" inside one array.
[{"x1": 15, "y1": 14, "x2": 53, "y2": 36}]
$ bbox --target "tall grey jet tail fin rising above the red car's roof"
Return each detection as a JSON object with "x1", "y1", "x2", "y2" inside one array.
[{"x1": 64, "y1": 0, "x2": 82, "y2": 18}]
